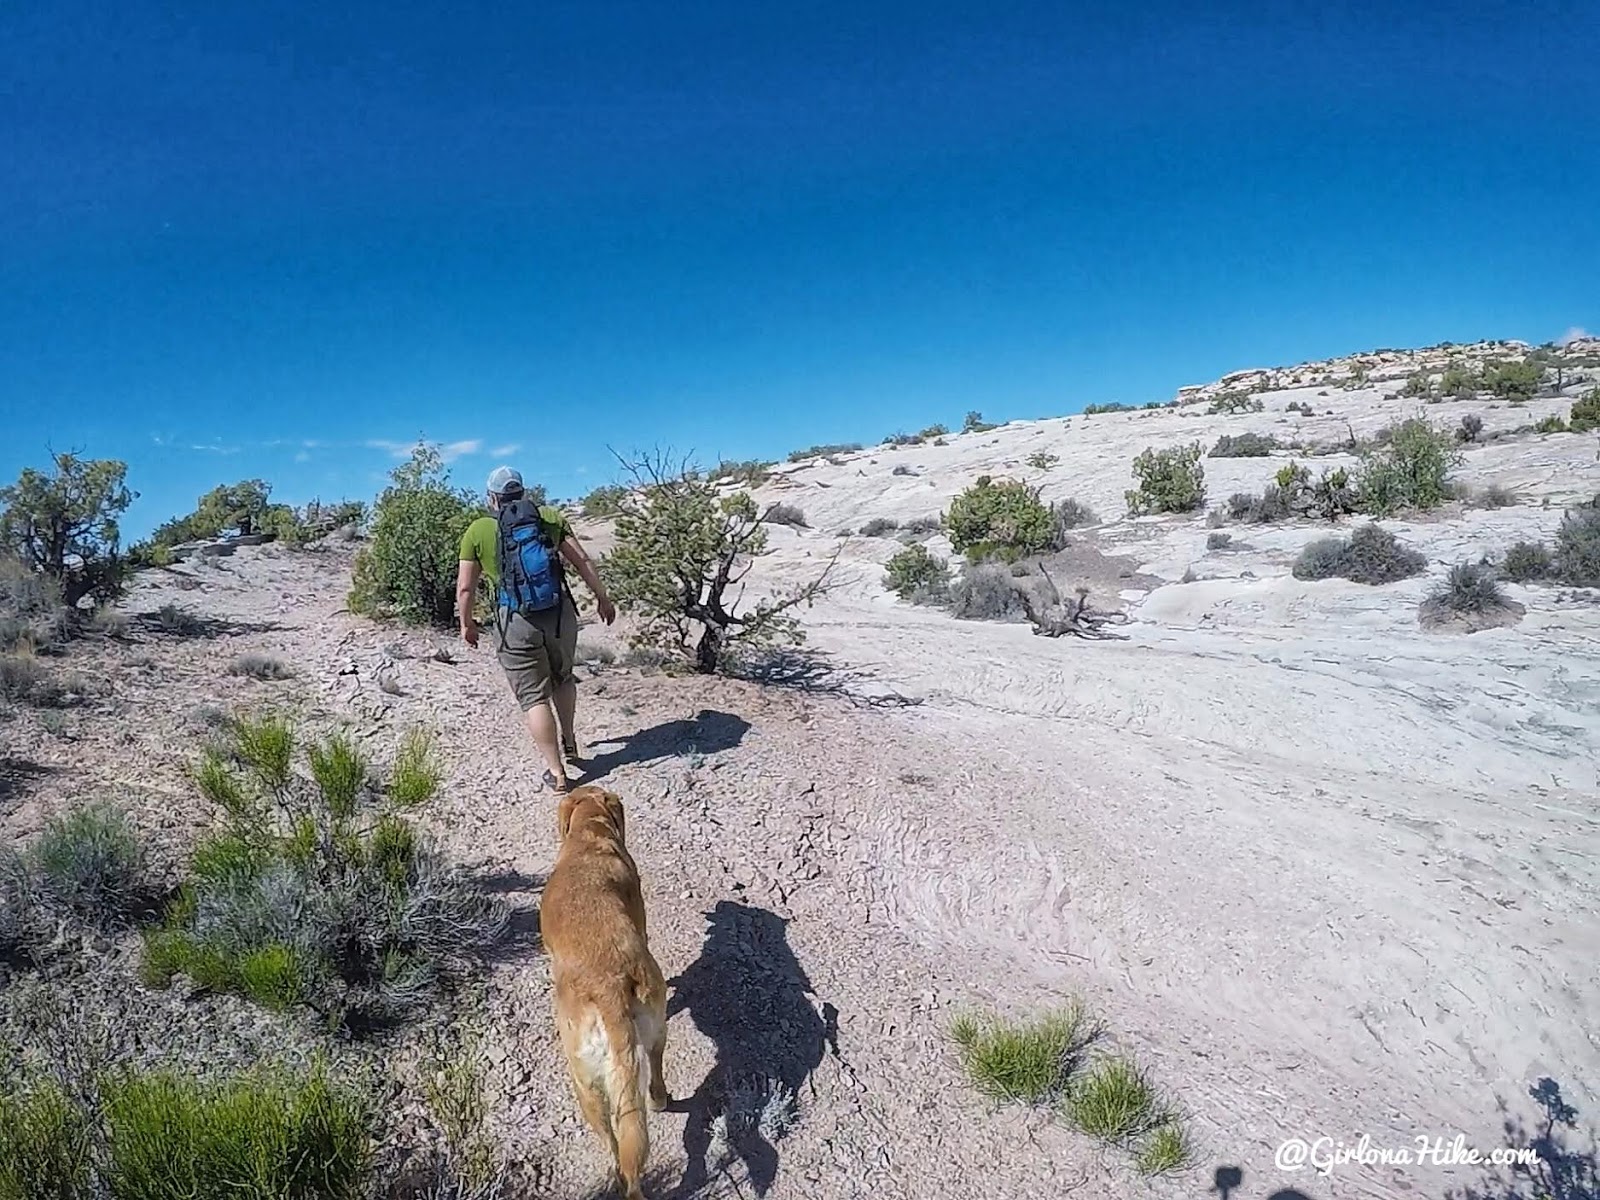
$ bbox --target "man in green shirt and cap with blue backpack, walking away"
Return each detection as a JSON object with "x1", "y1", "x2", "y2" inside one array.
[{"x1": 456, "y1": 467, "x2": 616, "y2": 795}]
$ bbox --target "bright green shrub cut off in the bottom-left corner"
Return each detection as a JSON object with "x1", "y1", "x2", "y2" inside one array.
[{"x1": 0, "y1": 1078, "x2": 93, "y2": 1200}]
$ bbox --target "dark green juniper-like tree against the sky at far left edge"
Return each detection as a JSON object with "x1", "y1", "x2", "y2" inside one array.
[{"x1": 0, "y1": 454, "x2": 138, "y2": 608}]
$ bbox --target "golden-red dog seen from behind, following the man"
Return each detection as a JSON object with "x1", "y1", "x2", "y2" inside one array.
[{"x1": 539, "y1": 784, "x2": 670, "y2": 1200}]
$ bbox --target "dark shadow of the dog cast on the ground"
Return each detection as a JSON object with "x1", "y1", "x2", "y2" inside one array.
[{"x1": 667, "y1": 901, "x2": 838, "y2": 1197}]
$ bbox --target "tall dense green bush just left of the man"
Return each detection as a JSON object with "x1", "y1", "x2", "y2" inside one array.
[{"x1": 349, "y1": 445, "x2": 489, "y2": 627}]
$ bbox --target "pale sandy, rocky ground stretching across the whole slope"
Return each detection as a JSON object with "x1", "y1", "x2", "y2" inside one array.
[{"x1": 0, "y1": 366, "x2": 1600, "y2": 1200}]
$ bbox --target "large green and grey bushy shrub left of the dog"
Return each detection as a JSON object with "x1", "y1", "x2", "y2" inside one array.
[{"x1": 144, "y1": 718, "x2": 507, "y2": 1030}]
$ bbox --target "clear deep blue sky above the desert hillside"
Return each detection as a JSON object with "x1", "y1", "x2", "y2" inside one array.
[{"x1": 0, "y1": 0, "x2": 1600, "y2": 533}]
